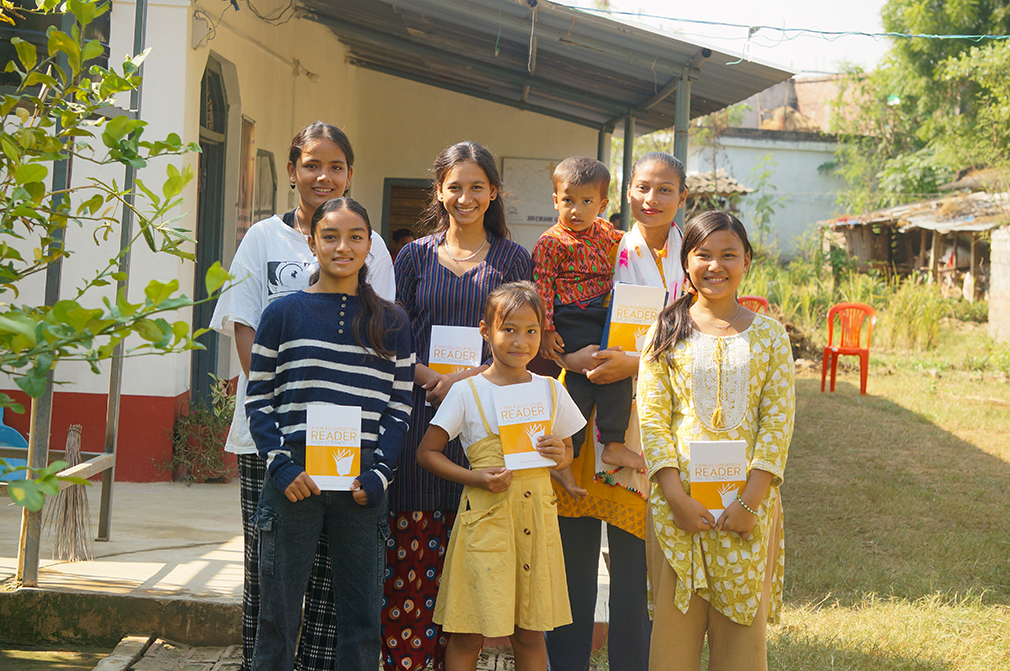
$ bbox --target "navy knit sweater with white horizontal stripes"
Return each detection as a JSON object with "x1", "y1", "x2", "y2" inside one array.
[{"x1": 245, "y1": 291, "x2": 414, "y2": 505}]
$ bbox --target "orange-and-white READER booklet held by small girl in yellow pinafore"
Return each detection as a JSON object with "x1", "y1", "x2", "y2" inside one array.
[{"x1": 494, "y1": 380, "x2": 558, "y2": 471}]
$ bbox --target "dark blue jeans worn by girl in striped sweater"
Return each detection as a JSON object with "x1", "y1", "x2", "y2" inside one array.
[{"x1": 253, "y1": 466, "x2": 389, "y2": 671}]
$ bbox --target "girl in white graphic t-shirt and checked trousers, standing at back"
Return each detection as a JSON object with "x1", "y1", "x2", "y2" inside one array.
[{"x1": 210, "y1": 121, "x2": 396, "y2": 671}]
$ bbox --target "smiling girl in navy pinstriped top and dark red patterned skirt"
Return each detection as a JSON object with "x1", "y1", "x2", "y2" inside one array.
[{"x1": 383, "y1": 141, "x2": 532, "y2": 671}]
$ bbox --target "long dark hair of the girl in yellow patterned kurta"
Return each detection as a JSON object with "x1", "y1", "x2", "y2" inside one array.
[{"x1": 648, "y1": 210, "x2": 753, "y2": 364}]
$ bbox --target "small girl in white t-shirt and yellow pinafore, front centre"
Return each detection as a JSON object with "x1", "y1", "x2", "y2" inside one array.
[{"x1": 417, "y1": 282, "x2": 586, "y2": 671}]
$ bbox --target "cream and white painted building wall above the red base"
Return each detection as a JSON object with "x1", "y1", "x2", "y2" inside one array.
[{"x1": 0, "y1": 0, "x2": 597, "y2": 404}]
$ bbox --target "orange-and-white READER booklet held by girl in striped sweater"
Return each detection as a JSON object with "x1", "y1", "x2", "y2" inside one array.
[{"x1": 305, "y1": 403, "x2": 362, "y2": 491}]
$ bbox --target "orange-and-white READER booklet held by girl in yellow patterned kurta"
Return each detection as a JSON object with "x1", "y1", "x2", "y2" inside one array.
[{"x1": 691, "y1": 441, "x2": 747, "y2": 519}]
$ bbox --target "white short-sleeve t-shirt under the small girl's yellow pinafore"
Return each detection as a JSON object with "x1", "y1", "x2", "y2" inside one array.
[{"x1": 431, "y1": 373, "x2": 586, "y2": 458}]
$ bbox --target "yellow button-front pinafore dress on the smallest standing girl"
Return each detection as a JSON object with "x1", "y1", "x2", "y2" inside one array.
[{"x1": 433, "y1": 380, "x2": 572, "y2": 637}]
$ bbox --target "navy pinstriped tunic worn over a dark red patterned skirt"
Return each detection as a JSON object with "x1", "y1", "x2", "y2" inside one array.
[{"x1": 389, "y1": 232, "x2": 533, "y2": 512}]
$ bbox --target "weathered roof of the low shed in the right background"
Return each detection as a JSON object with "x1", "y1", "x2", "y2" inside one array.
[{"x1": 818, "y1": 192, "x2": 1010, "y2": 234}]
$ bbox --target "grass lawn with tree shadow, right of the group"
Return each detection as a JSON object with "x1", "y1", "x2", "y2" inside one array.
[{"x1": 769, "y1": 322, "x2": 1010, "y2": 671}]
